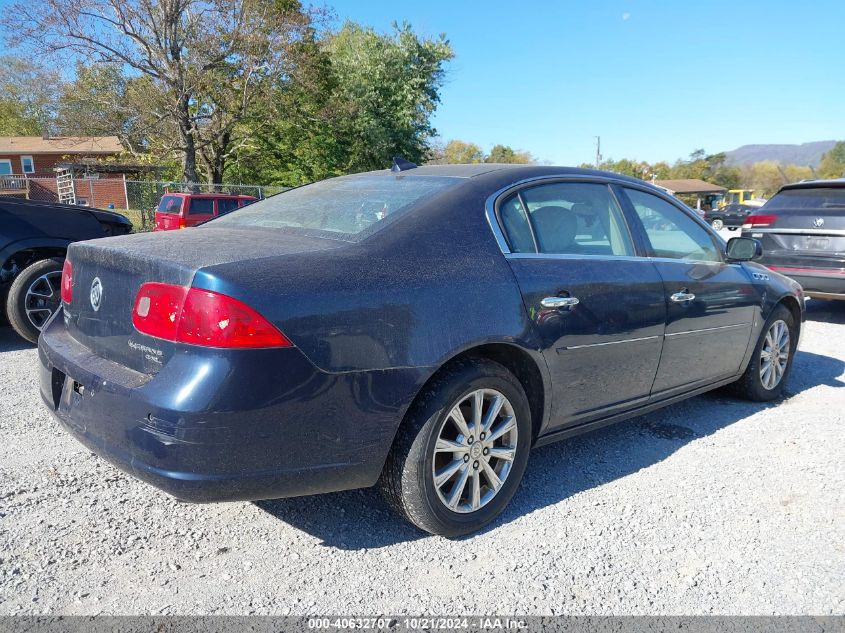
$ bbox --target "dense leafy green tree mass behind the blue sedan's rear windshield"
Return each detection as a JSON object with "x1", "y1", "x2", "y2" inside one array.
[{"x1": 228, "y1": 22, "x2": 452, "y2": 185}]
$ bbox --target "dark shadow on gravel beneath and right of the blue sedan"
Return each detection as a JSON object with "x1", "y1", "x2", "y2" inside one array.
[{"x1": 257, "y1": 351, "x2": 845, "y2": 550}]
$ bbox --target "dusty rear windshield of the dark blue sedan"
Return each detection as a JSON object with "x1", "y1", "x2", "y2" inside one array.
[{"x1": 208, "y1": 175, "x2": 461, "y2": 241}]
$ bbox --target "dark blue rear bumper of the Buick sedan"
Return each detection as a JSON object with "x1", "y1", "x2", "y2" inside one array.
[{"x1": 38, "y1": 317, "x2": 420, "y2": 502}]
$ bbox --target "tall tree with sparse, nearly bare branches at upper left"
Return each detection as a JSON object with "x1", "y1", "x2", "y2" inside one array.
[{"x1": 0, "y1": 0, "x2": 312, "y2": 182}]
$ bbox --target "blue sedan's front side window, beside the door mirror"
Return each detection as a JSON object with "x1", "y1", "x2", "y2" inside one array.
[{"x1": 625, "y1": 188, "x2": 722, "y2": 262}]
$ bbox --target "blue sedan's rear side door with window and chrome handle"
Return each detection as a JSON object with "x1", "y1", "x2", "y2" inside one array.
[{"x1": 496, "y1": 180, "x2": 666, "y2": 430}]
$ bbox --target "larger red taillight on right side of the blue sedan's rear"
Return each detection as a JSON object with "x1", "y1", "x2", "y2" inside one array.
[{"x1": 132, "y1": 283, "x2": 293, "y2": 348}]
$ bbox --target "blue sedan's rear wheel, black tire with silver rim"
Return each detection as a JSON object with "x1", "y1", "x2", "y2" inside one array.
[{"x1": 379, "y1": 359, "x2": 532, "y2": 537}]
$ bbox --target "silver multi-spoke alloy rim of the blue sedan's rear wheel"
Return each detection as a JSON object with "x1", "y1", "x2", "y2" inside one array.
[{"x1": 432, "y1": 389, "x2": 519, "y2": 514}]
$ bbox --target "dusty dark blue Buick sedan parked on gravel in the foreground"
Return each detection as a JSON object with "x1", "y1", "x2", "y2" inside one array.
[{"x1": 39, "y1": 164, "x2": 803, "y2": 536}]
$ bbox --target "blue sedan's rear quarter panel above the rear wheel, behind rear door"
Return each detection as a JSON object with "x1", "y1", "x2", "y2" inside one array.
[{"x1": 194, "y1": 182, "x2": 530, "y2": 372}]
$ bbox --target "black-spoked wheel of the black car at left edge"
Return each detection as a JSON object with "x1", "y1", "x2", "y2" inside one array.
[{"x1": 6, "y1": 257, "x2": 64, "y2": 343}]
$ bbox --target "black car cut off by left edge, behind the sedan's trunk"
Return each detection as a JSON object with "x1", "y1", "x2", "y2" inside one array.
[{"x1": 0, "y1": 196, "x2": 132, "y2": 343}]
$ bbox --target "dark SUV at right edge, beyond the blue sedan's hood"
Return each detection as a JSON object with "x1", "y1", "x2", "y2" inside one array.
[{"x1": 742, "y1": 179, "x2": 845, "y2": 300}]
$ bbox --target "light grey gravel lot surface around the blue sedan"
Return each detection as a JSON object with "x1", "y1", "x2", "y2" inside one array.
[{"x1": 0, "y1": 302, "x2": 845, "y2": 615}]
